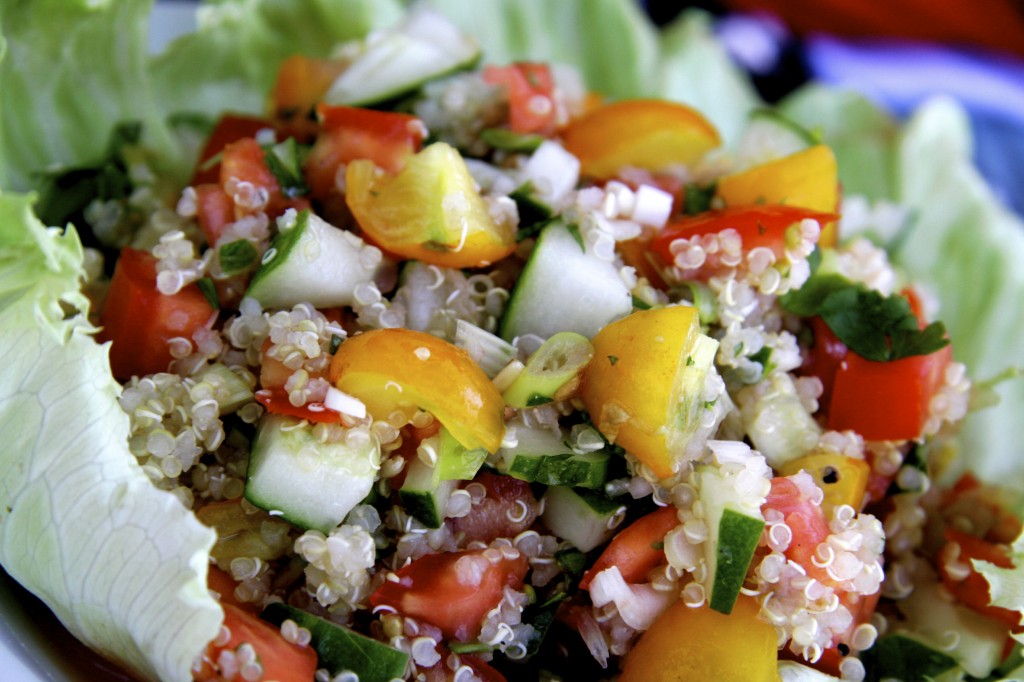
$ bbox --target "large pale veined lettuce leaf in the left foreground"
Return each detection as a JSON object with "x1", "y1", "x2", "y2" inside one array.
[{"x1": 0, "y1": 194, "x2": 223, "y2": 681}]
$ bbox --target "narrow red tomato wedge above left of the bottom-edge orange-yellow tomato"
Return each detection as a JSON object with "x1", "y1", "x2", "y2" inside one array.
[{"x1": 580, "y1": 505, "x2": 679, "y2": 590}]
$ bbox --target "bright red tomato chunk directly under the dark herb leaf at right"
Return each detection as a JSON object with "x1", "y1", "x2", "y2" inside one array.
[{"x1": 826, "y1": 345, "x2": 952, "y2": 440}]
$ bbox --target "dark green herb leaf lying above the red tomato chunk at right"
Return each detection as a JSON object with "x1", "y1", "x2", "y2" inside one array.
[{"x1": 781, "y1": 273, "x2": 949, "y2": 363}]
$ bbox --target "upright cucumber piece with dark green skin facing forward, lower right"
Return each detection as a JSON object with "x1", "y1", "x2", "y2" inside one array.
[{"x1": 694, "y1": 465, "x2": 765, "y2": 613}]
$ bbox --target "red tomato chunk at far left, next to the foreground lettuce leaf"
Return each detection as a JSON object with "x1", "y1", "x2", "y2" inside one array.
[{"x1": 97, "y1": 248, "x2": 216, "y2": 381}]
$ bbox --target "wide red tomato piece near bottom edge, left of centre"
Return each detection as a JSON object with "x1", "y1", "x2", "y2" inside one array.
[{"x1": 370, "y1": 549, "x2": 529, "y2": 641}]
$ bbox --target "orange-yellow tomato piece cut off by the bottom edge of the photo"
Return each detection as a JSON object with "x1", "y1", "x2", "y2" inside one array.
[{"x1": 618, "y1": 595, "x2": 778, "y2": 682}]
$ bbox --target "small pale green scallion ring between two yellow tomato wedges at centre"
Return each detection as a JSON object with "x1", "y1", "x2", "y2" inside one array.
[{"x1": 502, "y1": 332, "x2": 594, "y2": 408}]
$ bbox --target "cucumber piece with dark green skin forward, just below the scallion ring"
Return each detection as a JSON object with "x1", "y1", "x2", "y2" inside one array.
[{"x1": 497, "y1": 427, "x2": 611, "y2": 488}]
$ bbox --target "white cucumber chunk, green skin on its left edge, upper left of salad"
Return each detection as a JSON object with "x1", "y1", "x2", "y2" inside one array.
[{"x1": 246, "y1": 211, "x2": 381, "y2": 308}]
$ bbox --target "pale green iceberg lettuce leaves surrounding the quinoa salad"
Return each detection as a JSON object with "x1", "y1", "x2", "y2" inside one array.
[{"x1": 0, "y1": 0, "x2": 1024, "y2": 680}]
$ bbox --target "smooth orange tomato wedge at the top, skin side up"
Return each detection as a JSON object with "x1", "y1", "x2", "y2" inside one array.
[{"x1": 562, "y1": 99, "x2": 722, "y2": 179}]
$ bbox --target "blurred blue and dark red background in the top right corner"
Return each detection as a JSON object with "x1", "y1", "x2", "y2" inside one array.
[{"x1": 642, "y1": 0, "x2": 1024, "y2": 215}]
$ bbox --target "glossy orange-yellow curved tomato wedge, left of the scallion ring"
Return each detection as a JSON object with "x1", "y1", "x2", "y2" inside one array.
[{"x1": 328, "y1": 329, "x2": 505, "y2": 453}]
